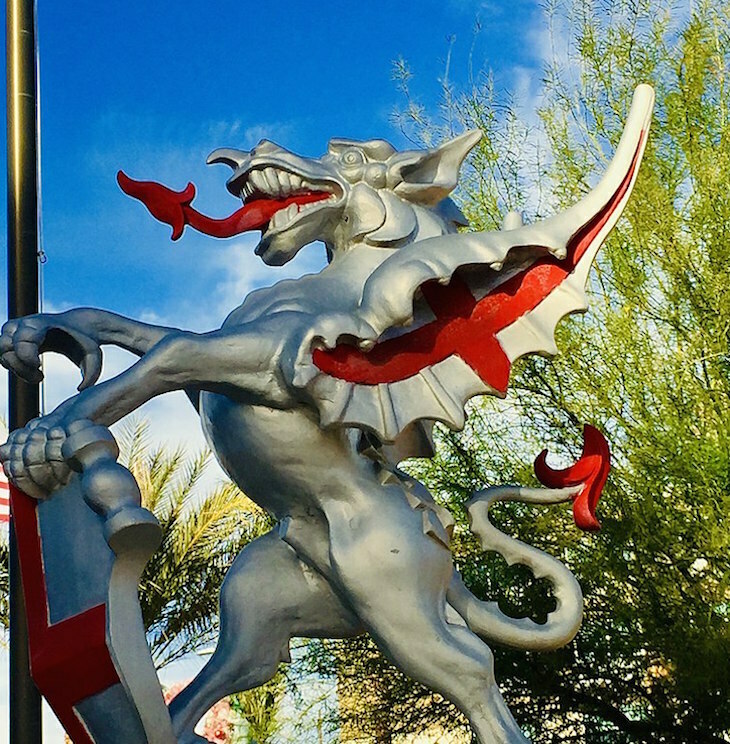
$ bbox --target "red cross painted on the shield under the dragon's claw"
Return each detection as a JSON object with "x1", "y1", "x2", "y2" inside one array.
[{"x1": 10, "y1": 485, "x2": 119, "y2": 744}]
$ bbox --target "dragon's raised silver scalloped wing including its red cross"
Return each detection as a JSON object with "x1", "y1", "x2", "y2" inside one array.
[{"x1": 292, "y1": 85, "x2": 654, "y2": 454}]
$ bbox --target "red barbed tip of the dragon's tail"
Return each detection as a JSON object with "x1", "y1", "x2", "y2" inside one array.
[{"x1": 535, "y1": 424, "x2": 611, "y2": 532}]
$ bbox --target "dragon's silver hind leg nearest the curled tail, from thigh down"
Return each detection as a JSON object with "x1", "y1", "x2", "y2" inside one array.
[{"x1": 327, "y1": 487, "x2": 527, "y2": 744}]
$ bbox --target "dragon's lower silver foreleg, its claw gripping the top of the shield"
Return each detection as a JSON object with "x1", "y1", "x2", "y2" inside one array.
[{"x1": 0, "y1": 314, "x2": 297, "y2": 499}]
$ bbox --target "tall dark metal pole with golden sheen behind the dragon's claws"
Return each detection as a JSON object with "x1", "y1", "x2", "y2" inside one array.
[{"x1": 6, "y1": 0, "x2": 42, "y2": 744}]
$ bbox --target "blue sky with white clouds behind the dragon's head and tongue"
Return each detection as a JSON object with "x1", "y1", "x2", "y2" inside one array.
[{"x1": 0, "y1": 0, "x2": 544, "y2": 742}]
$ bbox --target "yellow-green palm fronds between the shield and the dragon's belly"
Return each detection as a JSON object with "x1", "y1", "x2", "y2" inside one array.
[{"x1": 118, "y1": 423, "x2": 271, "y2": 668}]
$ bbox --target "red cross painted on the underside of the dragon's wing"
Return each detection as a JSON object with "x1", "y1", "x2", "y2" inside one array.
[{"x1": 312, "y1": 132, "x2": 644, "y2": 393}]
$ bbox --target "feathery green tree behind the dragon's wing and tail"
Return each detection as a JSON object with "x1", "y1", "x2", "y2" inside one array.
[{"x1": 330, "y1": 0, "x2": 730, "y2": 744}]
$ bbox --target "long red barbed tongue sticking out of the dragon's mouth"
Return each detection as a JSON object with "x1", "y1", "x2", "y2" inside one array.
[{"x1": 117, "y1": 171, "x2": 330, "y2": 240}]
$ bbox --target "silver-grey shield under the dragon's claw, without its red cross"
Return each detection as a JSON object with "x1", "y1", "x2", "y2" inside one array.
[{"x1": 44, "y1": 428, "x2": 175, "y2": 744}]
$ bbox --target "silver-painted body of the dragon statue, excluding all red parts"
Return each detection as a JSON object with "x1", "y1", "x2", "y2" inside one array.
[{"x1": 0, "y1": 86, "x2": 653, "y2": 744}]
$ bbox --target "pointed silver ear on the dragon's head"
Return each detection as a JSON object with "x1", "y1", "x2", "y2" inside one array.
[{"x1": 388, "y1": 129, "x2": 482, "y2": 207}]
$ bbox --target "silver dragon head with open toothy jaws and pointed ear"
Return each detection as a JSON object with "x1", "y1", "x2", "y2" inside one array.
[{"x1": 208, "y1": 130, "x2": 481, "y2": 266}]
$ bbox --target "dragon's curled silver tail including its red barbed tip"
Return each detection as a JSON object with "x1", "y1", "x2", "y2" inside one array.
[{"x1": 447, "y1": 426, "x2": 609, "y2": 651}]
